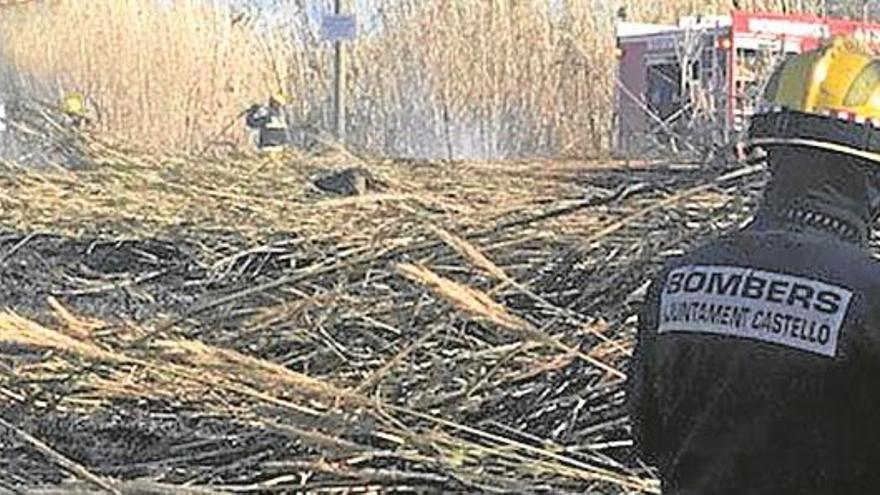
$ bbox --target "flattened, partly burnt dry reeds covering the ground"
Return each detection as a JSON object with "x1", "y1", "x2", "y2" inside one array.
[{"x1": 0, "y1": 102, "x2": 762, "y2": 494}]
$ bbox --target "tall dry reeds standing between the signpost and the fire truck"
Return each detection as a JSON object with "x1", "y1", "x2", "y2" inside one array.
[{"x1": 340, "y1": 0, "x2": 613, "y2": 157}]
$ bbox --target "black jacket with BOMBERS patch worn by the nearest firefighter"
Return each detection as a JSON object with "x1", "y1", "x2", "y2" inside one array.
[{"x1": 628, "y1": 215, "x2": 880, "y2": 495}]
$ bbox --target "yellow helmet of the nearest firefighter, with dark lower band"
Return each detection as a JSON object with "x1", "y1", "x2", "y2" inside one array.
[{"x1": 748, "y1": 38, "x2": 880, "y2": 162}]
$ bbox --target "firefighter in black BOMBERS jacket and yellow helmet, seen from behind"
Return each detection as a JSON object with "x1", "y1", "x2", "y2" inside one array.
[{"x1": 628, "y1": 40, "x2": 880, "y2": 495}]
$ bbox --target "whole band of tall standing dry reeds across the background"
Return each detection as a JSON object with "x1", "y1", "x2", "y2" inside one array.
[{"x1": 0, "y1": 0, "x2": 840, "y2": 157}]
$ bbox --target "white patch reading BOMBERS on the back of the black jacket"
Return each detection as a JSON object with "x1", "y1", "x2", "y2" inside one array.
[{"x1": 658, "y1": 265, "x2": 852, "y2": 357}]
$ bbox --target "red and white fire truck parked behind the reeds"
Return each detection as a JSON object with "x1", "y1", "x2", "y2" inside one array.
[{"x1": 615, "y1": 11, "x2": 880, "y2": 152}]
